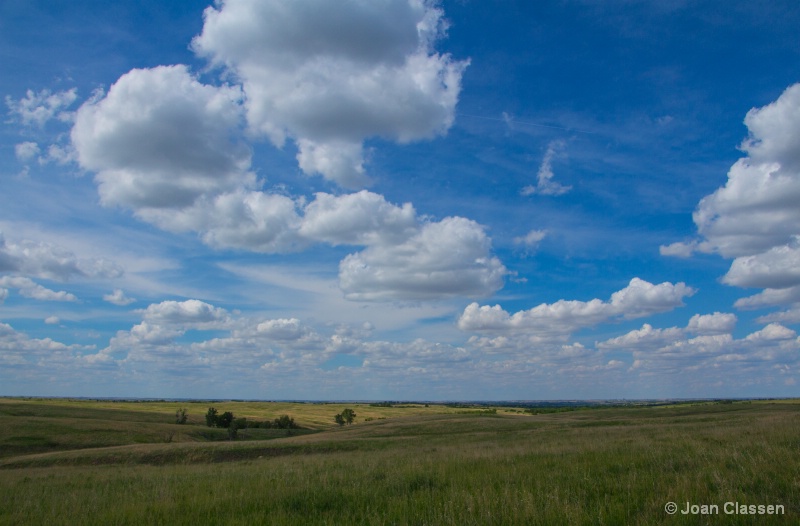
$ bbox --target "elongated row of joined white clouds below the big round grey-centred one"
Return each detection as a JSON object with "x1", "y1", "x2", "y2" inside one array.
[{"x1": 144, "y1": 190, "x2": 507, "y2": 301}]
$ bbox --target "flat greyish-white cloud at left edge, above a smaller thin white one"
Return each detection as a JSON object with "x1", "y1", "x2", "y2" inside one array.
[{"x1": 0, "y1": 232, "x2": 124, "y2": 281}]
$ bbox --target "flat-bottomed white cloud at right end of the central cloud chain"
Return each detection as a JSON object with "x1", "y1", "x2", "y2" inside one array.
[{"x1": 339, "y1": 217, "x2": 508, "y2": 301}]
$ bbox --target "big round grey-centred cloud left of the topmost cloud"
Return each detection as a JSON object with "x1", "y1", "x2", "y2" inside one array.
[{"x1": 72, "y1": 65, "x2": 255, "y2": 212}]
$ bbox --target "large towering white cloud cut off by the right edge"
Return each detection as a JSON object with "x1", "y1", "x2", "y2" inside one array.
[{"x1": 661, "y1": 84, "x2": 800, "y2": 300}]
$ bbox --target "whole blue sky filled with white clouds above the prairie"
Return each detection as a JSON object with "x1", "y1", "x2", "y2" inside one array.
[{"x1": 0, "y1": 0, "x2": 800, "y2": 401}]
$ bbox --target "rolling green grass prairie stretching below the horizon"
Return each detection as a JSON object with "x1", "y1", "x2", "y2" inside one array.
[{"x1": 0, "y1": 399, "x2": 800, "y2": 525}]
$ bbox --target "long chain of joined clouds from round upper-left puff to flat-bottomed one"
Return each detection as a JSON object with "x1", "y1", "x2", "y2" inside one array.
[{"x1": 67, "y1": 63, "x2": 506, "y2": 301}]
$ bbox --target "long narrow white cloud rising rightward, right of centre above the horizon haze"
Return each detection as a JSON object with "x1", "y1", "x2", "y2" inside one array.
[{"x1": 458, "y1": 278, "x2": 694, "y2": 334}]
